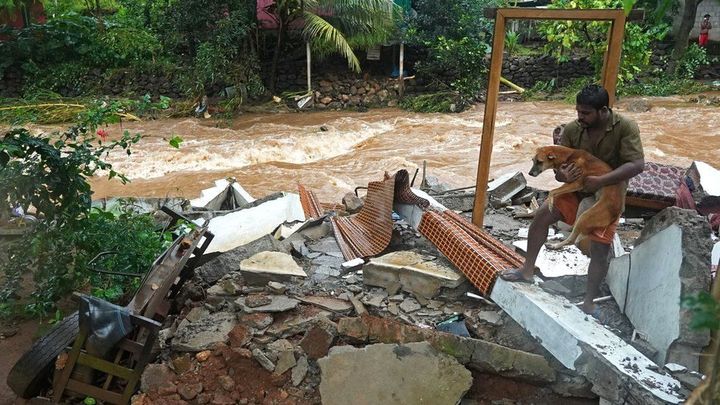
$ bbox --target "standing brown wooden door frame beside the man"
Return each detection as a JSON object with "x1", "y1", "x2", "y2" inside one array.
[{"x1": 473, "y1": 8, "x2": 644, "y2": 228}]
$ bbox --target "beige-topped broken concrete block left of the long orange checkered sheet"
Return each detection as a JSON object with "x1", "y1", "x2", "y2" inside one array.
[{"x1": 363, "y1": 251, "x2": 465, "y2": 298}]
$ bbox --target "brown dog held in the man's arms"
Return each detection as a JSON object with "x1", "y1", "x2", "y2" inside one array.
[{"x1": 529, "y1": 146, "x2": 622, "y2": 249}]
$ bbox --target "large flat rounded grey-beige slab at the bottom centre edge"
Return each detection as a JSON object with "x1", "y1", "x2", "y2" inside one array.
[{"x1": 318, "y1": 342, "x2": 472, "y2": 405}]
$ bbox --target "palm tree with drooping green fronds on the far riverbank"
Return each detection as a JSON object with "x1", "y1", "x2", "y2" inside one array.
[{"x1": 267, "y1": 0, "x2": 397, "y2": 91}]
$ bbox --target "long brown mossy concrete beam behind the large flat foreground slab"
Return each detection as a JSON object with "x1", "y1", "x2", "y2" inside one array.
[{"x1": 338, "y1": 315, "x2": 555, "y2": 383}]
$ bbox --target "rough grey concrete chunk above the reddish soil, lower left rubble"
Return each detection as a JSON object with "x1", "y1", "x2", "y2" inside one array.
[{"x1": 171, "y1": 312, "x2": 237, "y2": 352}]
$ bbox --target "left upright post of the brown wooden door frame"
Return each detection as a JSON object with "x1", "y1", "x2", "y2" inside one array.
[{"x1": 473, "y1": 10, "x2": 505, "y2": 228}]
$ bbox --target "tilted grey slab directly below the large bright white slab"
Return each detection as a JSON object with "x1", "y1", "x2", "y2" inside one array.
[{"x1": 195, "y1": 235, "x2": 289, "y2": 285}]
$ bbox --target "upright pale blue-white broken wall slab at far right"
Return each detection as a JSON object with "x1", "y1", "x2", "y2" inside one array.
[{"x1": 607, "y1": 207, "x2": 712, "y2": 370}]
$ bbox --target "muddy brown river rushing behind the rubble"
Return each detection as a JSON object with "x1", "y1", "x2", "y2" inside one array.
[{"x1": 81, "y1": 97, "x2": 720, "y2": 202}]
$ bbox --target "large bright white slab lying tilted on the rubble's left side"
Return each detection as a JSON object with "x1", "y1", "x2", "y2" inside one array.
[{"x1": 200, "y1": 193, "x2": 305, "y2": 253}]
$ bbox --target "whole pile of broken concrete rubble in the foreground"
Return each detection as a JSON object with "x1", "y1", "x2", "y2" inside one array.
[{"x1": 60, "y1": 166, "x2": 710, "y2": 404}]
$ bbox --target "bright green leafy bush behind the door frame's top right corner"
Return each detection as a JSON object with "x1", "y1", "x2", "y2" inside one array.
[{"x1": 539, "y1": 0, "x2": 669, "y2": 83}]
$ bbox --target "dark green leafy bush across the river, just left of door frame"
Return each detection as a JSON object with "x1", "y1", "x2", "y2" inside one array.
[{"x1": 406, "y1": 0, "x2": 494, "y2": 100}]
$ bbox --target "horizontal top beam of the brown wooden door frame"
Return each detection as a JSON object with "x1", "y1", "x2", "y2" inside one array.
[{"x1": 485, "y1": 7, "x2": 645, "y2": 21}]
